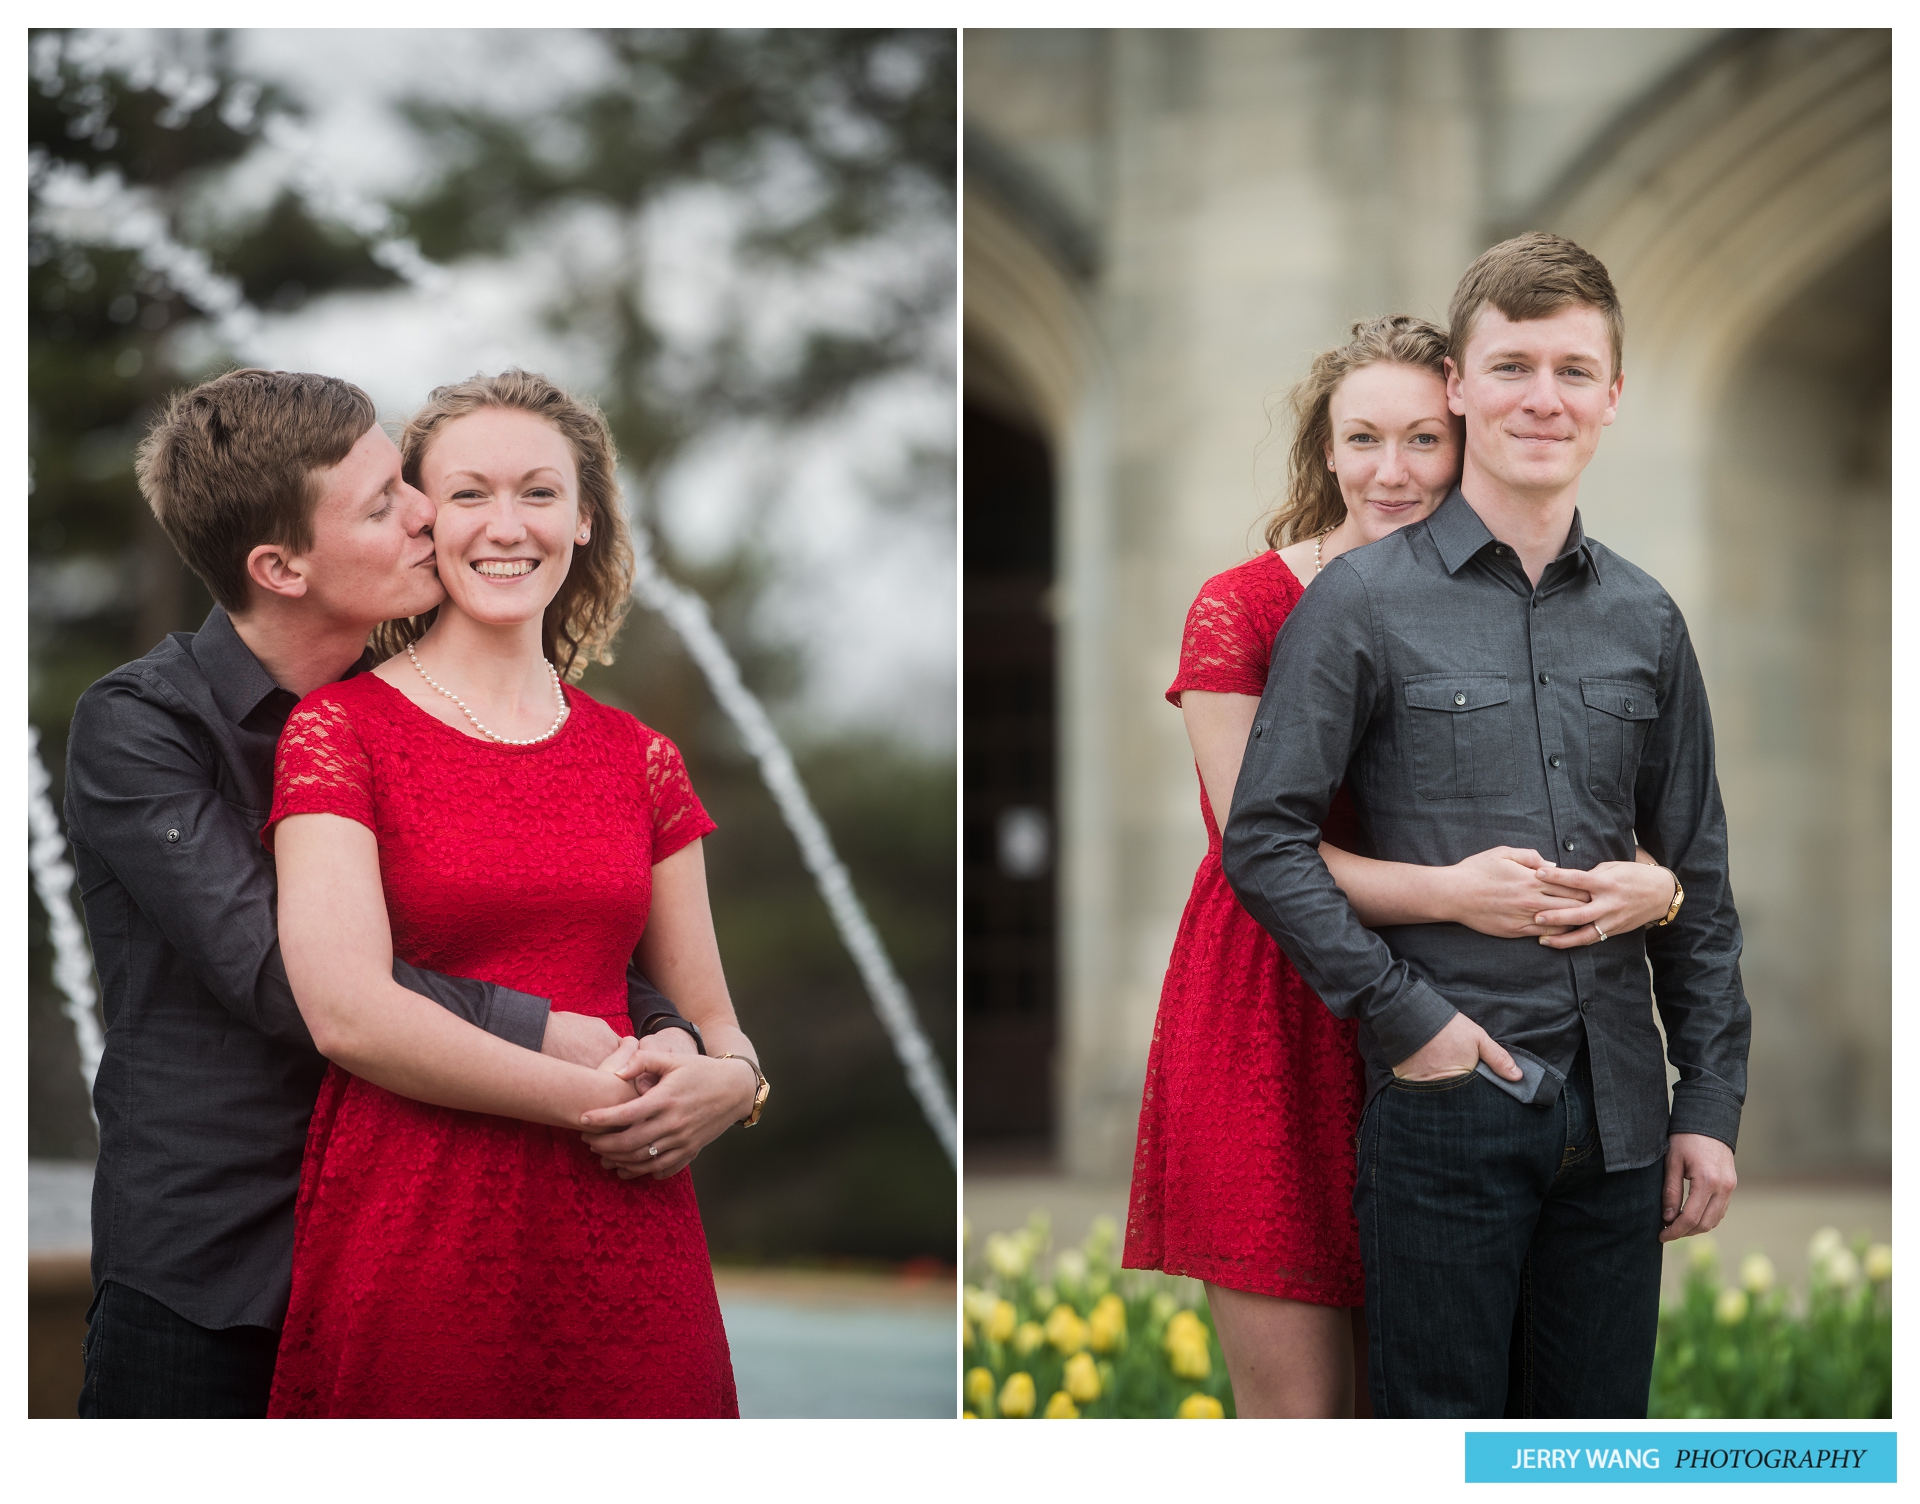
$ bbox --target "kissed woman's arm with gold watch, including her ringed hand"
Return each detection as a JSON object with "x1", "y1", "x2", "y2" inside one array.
[{"x1": 586, "y1": 841, "x2": 760, "y2": 1179}]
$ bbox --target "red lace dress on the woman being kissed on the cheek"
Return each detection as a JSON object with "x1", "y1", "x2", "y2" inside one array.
[{"x1": 265, "y1": 674, "x2": 739, "y2": 1416}]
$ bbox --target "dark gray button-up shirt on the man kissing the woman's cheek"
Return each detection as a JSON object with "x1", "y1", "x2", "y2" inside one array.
[{"x1": 67, "y1": 607, "x2": 672, "y2": 1327}]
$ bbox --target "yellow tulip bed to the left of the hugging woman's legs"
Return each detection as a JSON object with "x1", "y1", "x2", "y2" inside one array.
[{"x1": 962, "y1": 1212, "x2": 1236, "y2": 1419}]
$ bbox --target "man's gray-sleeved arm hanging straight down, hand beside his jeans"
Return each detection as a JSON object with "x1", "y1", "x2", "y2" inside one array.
[{"x1": 1634, "y1": 607, "x2": 1753, "y2": 1239}]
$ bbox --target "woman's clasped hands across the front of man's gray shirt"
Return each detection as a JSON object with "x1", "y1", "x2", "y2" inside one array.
[{"x1": 1448, "y1": 845, "x2": 1674, "y2": 951}]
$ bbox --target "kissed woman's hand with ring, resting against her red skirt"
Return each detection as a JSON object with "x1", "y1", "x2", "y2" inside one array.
[{"x1": 580, "y1": 1030, "x2": 758, "y2": 1179}]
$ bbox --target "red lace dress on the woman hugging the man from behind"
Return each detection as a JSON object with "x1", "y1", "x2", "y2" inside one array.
[{"x1": 1121, "y1": 553, "x2": 1363, "y2": 1306}]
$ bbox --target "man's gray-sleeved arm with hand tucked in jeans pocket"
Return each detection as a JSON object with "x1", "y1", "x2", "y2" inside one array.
[{"x1": 1221, "y1": 559, "x2": 1519, "y2": 1079}]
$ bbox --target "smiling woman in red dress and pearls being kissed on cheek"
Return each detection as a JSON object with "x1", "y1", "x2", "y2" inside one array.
[{"x1": 265, "y1": 371, "x2": 764, "y2": 1416}]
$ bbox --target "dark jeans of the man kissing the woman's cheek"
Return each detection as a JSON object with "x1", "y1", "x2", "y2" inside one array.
[{"x1": 81, "y1": 1279, "x2": 280, "y2": 1419}]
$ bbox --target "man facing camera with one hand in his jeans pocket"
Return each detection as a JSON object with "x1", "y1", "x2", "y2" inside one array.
[{"x1": 1225, "y1": 234, "x2": 1749, "y2": 1418}]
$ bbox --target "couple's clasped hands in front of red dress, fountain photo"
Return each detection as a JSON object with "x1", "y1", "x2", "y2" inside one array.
[{"x1": 541, "y1": 1012, "x2": 758, "y2": 1179}]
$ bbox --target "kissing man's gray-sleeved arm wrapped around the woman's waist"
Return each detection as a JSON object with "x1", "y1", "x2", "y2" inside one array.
[{"x1": 67, "y1": 680, "x2": 547, "y2": 1051}]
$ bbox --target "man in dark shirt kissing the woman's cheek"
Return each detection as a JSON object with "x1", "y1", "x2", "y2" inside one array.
[{"x1": 67, "y1": 371, "x2": 724, "y2": 1416}]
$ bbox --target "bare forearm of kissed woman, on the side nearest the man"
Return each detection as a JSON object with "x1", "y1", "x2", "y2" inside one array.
[{"x1": 273, "y1": 814, "x2": 634, "y2": 1128}]
